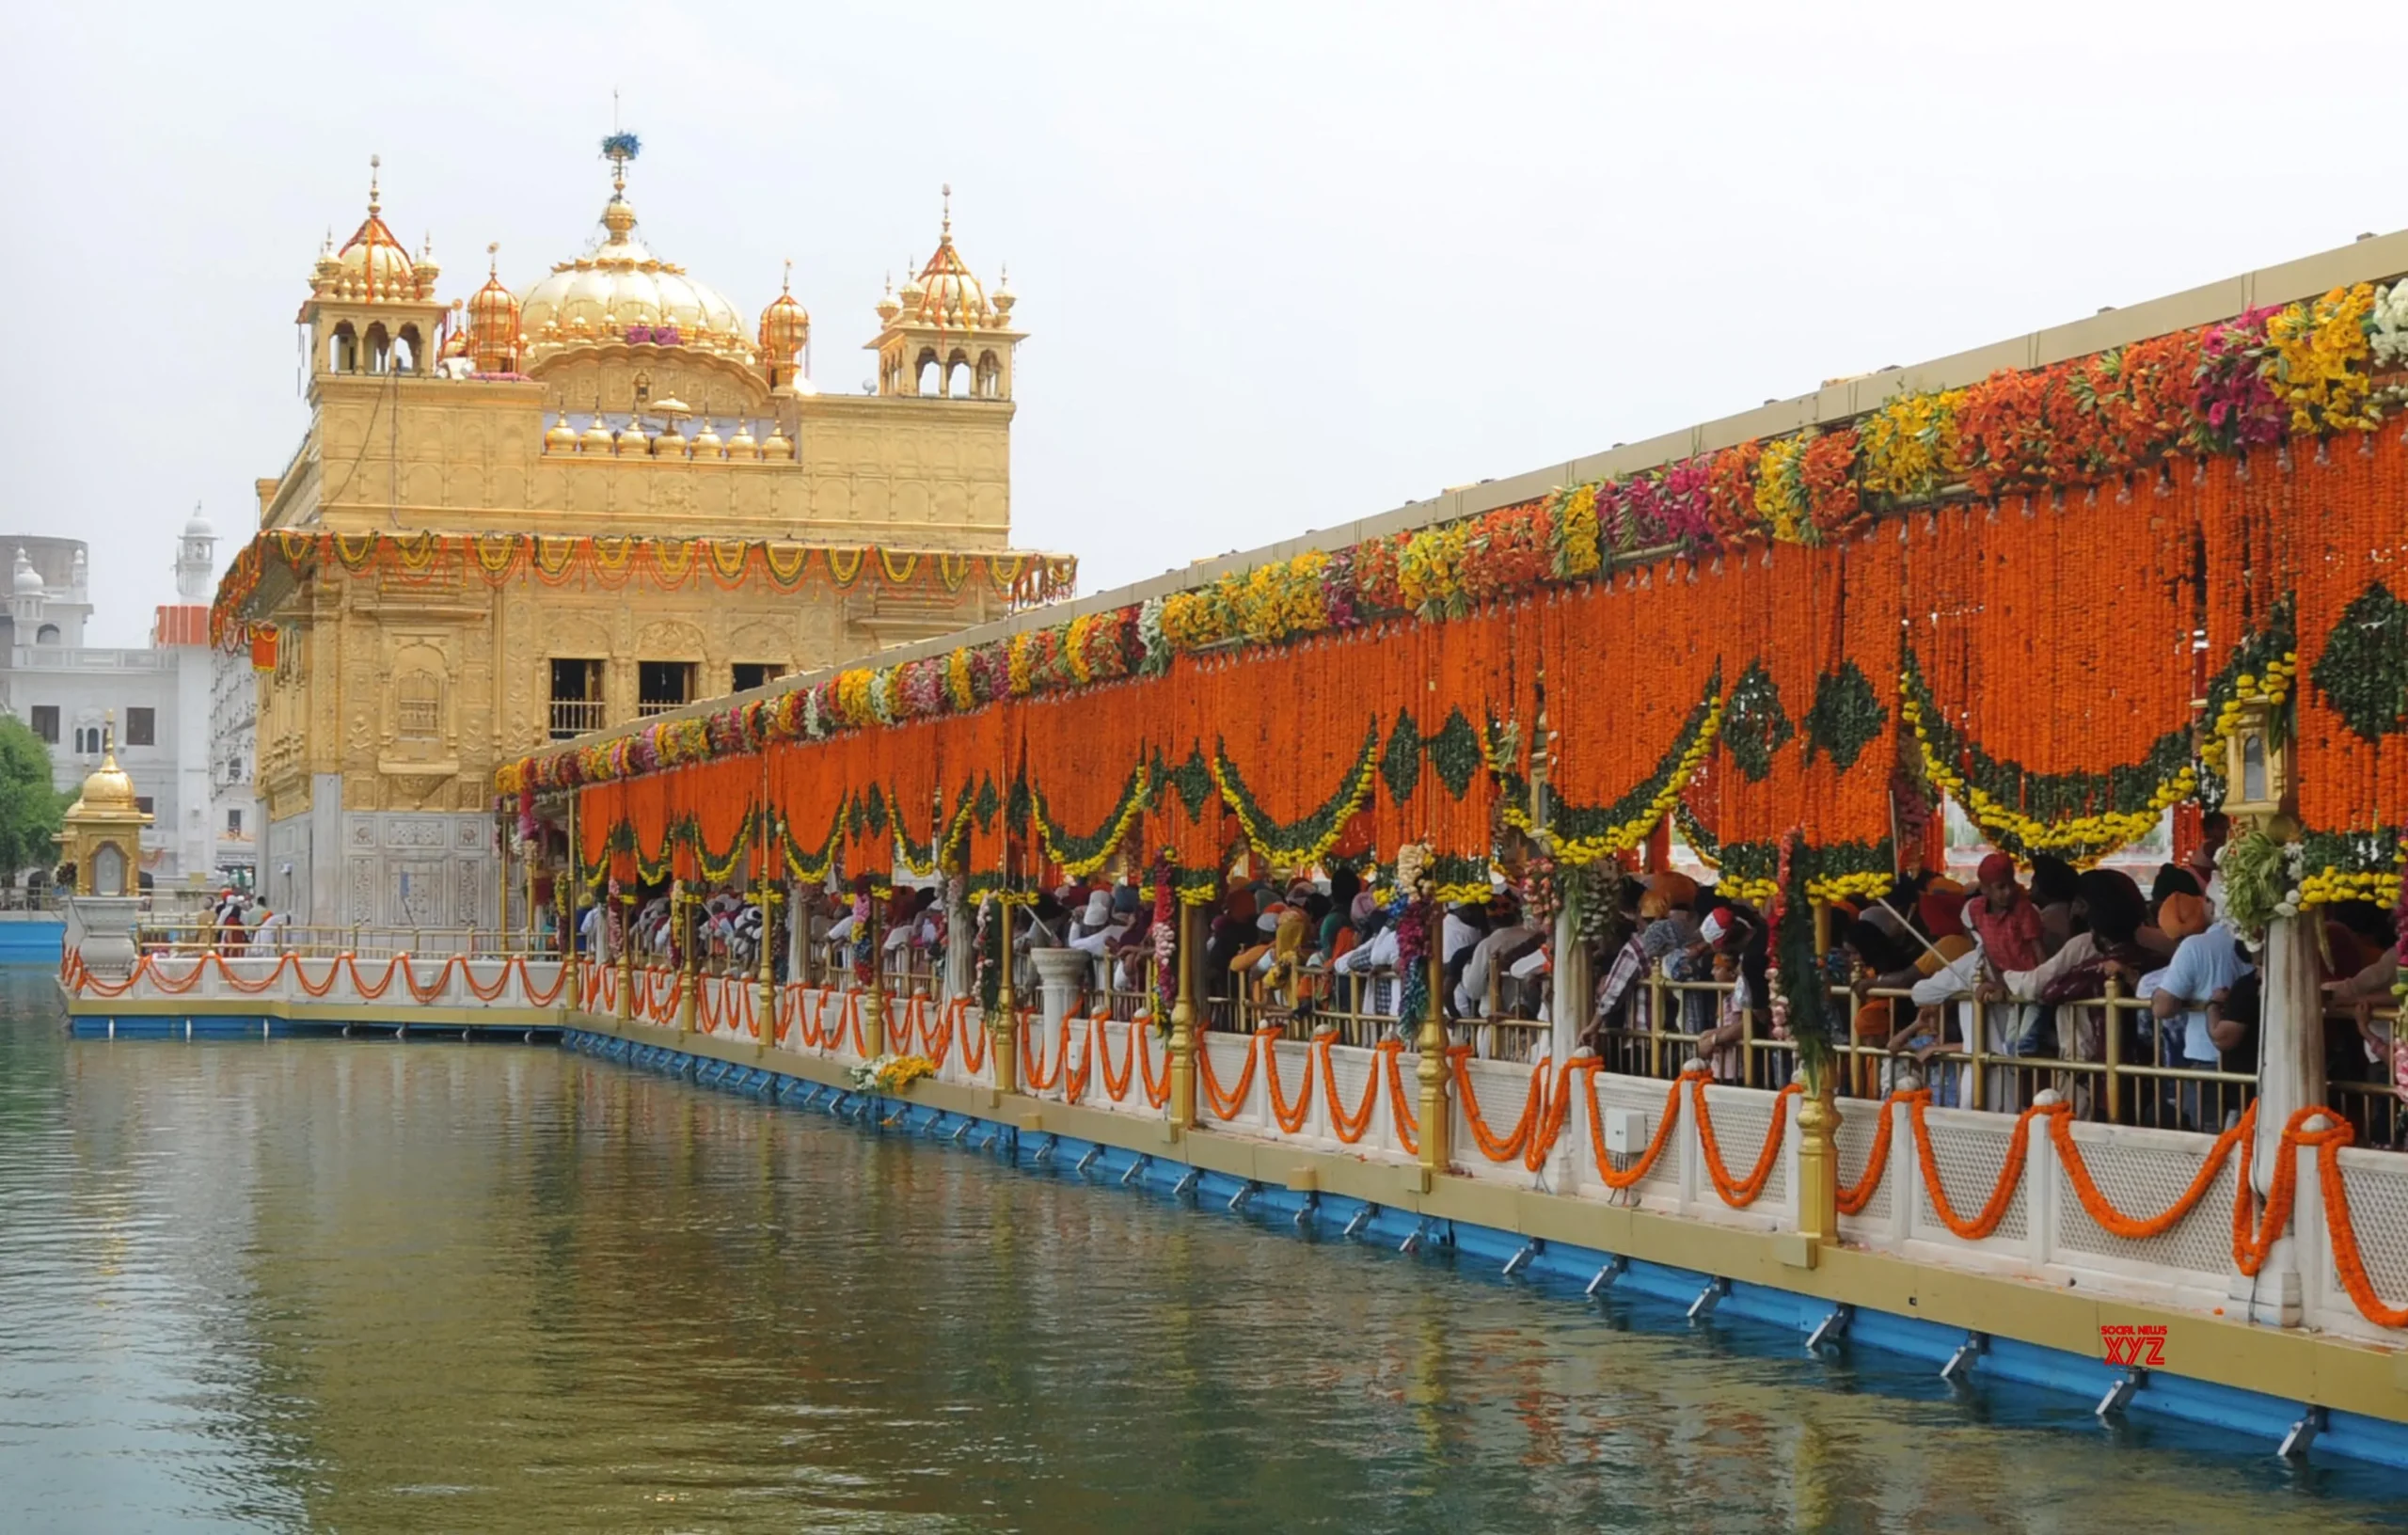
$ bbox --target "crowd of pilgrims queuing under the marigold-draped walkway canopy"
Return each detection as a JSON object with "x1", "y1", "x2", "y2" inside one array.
[{"x1": 580, "y1": 818, "x2": 2396, "y2": 1129}]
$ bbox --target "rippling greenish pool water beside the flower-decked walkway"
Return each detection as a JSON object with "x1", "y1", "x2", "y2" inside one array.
[{"x1": 0, "y1": 972, "x2": 2408, "y2": 1535}]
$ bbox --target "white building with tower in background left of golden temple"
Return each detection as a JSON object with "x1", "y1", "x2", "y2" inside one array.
[{"x1": 0, "y1": 513, "x2": 255, "y2": 885}]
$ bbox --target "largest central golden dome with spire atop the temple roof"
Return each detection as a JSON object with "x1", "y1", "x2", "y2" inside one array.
[{"x1": 517, "y1": 164, "x2": 753, "y2": 363}]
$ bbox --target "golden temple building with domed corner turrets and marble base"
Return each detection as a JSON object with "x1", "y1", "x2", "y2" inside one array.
[{"x1": 230, "y1": 147, "x2": 1074, "y2": 928}]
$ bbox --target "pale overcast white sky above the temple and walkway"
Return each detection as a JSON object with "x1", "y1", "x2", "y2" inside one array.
[{"x1": 0, "y1": 0, "x2": 2408, "y2": 645}]
